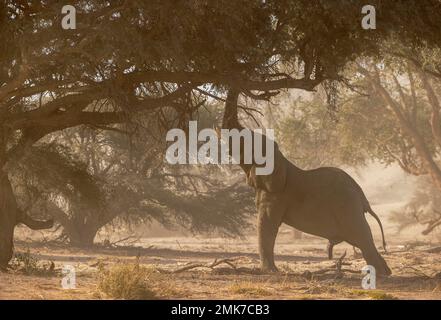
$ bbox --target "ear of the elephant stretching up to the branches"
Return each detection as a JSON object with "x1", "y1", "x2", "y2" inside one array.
[{"x1": 247, "y1": 144, "x2": 288, "y2": 192}]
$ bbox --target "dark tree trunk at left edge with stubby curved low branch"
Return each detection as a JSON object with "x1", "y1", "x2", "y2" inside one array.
[{"x1": 0, "y1": 170, "x2": 53, "y2": 268}]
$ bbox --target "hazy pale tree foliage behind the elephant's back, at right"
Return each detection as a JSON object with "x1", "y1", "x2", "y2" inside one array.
[{"x1": 280, "y1": 47, "x2": 441, "y2": 238}]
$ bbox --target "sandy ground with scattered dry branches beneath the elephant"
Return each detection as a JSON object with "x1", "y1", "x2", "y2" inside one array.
[{"x1": 0, "y1": 233, "x2": 441, "y2": 299}]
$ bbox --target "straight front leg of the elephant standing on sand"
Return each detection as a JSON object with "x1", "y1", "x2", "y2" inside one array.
[{"x1": 257, "y1": 198, "x2": 282, "y2": 272}]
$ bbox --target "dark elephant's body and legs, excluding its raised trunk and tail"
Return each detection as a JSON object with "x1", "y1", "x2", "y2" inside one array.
[{"x1": 248, "y1": 145, "x2": 391, "y2": 275}]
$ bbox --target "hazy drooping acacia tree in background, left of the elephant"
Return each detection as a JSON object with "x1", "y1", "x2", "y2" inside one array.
[{"x1": 13, "y1": 118, "x2": 253, "y2": 246}]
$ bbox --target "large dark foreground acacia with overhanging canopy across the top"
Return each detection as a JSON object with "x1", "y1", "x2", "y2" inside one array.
[{"x1": 0, "y1": 0, "x2": 441, "y2": 265}]
